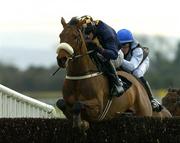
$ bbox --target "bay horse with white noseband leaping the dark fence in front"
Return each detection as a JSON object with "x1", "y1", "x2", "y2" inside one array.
[{"x1": 57, "y1": 18, "x2": 172, "y2": 132}]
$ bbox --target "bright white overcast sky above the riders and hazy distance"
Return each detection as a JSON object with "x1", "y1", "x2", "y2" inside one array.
[{"x1": 0, "y1": 0, "x2": 180, "y2": 68}]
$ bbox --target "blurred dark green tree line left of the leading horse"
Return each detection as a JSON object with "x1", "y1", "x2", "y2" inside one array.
[{"x1": 0, "y1": 63, "x2": 65, "y2": 92}]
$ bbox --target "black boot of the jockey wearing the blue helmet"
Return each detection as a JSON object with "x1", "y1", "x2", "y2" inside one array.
[{"x1": 140, "y1": 77, "x2": 163, "y2": 112}]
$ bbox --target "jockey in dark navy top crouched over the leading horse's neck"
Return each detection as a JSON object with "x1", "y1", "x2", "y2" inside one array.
[{"x1": 80, "y1": 16, "x2": 124, "y2": 97}]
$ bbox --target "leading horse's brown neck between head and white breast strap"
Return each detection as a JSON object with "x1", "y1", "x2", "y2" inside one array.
[{"x1": 67, "y1": 55, "x2": 98, "y2": 76}]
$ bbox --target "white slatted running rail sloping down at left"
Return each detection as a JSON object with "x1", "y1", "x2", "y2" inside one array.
[{"x1": 0, "y1": 84, "x2": 64, "y2": 118}]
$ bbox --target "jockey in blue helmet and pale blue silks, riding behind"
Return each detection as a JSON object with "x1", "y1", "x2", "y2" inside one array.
[{"x1": 117, "y1": 29, "x2": 163, "y2": 112}]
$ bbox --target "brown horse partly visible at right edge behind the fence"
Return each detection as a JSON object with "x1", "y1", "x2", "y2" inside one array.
[{"x1": 162, "y1": 89, "x2": 180, "y2": 116}]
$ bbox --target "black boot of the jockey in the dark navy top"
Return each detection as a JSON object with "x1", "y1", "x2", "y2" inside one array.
[{"x1": 104, "y1": 61, "x2": 124, "y2": 97}]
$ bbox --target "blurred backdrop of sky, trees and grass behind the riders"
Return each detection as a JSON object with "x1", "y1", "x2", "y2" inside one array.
[{"x1": 0, "y1": 0, "x2": 180, "y2": 104}]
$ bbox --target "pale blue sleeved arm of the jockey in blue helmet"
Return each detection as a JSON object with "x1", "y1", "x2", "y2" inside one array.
[{"x1": 122, "y1": 48, "x2": 143, "y2": 72}]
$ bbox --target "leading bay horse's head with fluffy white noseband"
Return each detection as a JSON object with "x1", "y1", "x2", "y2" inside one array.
[{"x1": 57, "y1": 17, "x2": 87, "y2": 68}]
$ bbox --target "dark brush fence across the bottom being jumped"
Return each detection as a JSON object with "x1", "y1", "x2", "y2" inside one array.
[{"x1": 0, "y1": 116, "x2": 180, "y2": 143}]
